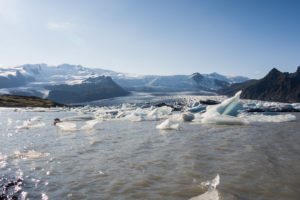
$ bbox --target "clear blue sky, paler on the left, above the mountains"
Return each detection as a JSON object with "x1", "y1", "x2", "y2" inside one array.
[{"x1": 0, "y1": 0, "x2": 300, "y2": 78}]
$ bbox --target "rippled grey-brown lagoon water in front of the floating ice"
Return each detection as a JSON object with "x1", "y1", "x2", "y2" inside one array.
[{"x1": 0, "y1": 94, "x2": 300, "y2": 200}]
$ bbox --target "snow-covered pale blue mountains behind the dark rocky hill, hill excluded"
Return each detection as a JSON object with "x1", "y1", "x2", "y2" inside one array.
[{"x1": 0, "y1": 64, "x2": 248, "y2": 97}]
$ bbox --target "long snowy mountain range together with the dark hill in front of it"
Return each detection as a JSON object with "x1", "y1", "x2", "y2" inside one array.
[{"x1": 0, "y1": 64, "x2": 248, "y2": 103}]
